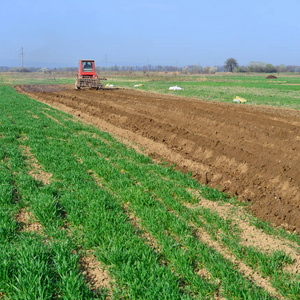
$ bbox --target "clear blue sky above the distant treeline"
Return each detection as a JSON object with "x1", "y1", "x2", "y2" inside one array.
[{"x1": 0, "y1": 0, "x2": 300, "y2": 67}]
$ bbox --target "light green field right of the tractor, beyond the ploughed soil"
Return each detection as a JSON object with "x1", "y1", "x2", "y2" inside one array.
[{"x1": 110, "y1": 75, "x2": 300, "y2": 109}]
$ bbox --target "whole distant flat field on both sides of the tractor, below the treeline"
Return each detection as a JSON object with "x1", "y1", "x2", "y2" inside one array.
[{"x1": 0, "y1": 72, "x2": 300, "y2": 109}]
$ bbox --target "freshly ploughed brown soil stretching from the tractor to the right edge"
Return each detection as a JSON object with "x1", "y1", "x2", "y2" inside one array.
[{"x1": 16, "y1": 85, "x2": 300, "y2": 232}]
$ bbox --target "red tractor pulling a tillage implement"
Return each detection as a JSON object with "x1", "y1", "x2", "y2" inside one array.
[{"x1": 75, "y1": 59, "x2": 106, "y2": 90}]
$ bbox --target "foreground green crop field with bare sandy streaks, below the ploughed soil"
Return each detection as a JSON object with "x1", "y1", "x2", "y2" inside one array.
[{"x1": 0, "y1": 85, "x2": 300, "y2": 300}]
